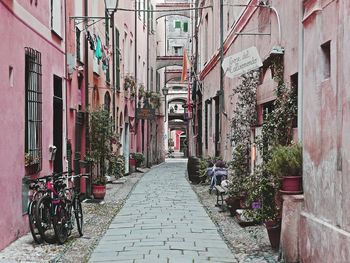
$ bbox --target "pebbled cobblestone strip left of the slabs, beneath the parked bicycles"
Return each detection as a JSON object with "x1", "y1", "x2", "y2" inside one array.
[{"x1": 0, "y1": 170, "x2": 147, "y2": 263}]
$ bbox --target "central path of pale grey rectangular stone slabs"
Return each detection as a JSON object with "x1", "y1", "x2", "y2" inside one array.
[{"x1": 90, "y1": 159, "x2": 237, "y2": 263}]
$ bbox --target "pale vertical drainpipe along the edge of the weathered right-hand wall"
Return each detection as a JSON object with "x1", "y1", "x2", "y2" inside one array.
[{"x1": 298, "y1": 3, "x2": 304, "y2": 143}]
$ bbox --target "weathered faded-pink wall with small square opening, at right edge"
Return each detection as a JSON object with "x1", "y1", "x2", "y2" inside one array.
[{"x1": 300, "y1": 0, "x2": 350, "y2": 262}]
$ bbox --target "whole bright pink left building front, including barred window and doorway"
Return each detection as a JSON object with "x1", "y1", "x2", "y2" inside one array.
[{"x1": 0, "y1": 0, "x2": 66, "y2": 249}]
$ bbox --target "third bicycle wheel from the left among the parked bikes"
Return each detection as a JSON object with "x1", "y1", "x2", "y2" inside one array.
[{"x1": 53, "y1": 204, "x2": 69, "y2": 245}]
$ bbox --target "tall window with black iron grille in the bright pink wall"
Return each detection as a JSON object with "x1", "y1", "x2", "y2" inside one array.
[{"x1": 25, "y1": 47, "x2": 42, "y2": 172}]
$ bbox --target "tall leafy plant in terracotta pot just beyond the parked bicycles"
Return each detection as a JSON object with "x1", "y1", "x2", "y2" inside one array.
[{"x1": 88, "y1": 108, "x2": 115, "y2": 199}]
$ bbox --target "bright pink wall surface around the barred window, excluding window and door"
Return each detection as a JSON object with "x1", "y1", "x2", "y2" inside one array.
[{"x1": 0, "y1": 1, "x2": 64, "y2": 250}]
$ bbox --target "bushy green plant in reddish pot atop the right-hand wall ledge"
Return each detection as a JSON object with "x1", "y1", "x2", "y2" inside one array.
[{"x1": 266, "y1": 143, "x2": 303, "y2": 194}]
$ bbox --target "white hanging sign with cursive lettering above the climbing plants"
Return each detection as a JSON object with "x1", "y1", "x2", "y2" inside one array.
[{"x1": 222, "y1": 46, "x2": 262, "y2": 78}]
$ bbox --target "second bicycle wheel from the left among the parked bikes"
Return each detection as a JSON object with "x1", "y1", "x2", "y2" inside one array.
[{"x1": 35, "y1": 195, "x2": 56, "y2": 244}]
